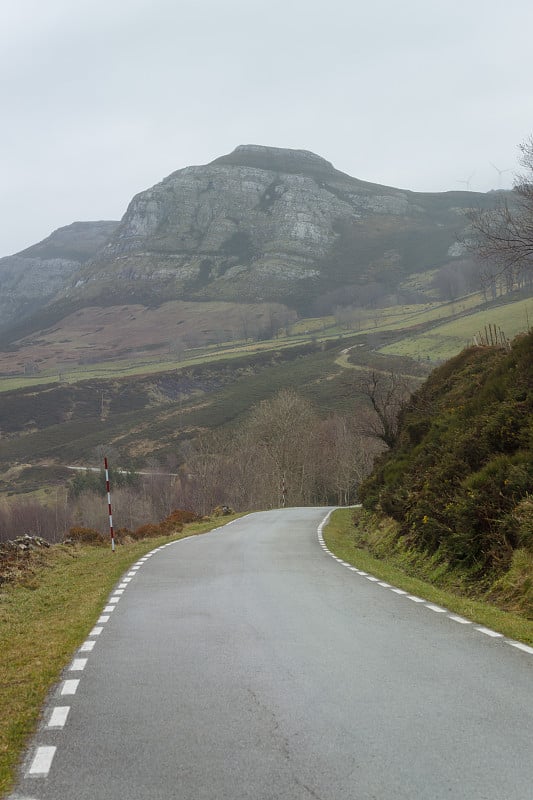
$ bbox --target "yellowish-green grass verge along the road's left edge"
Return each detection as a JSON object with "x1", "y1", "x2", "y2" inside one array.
[{"x1": 0, "y1": 515, "x2": 241, "y2": 797}]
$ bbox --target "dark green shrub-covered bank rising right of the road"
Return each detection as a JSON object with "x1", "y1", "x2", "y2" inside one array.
[{"x1": 360, "y1": 332, "x2": 533, "y2": 613}]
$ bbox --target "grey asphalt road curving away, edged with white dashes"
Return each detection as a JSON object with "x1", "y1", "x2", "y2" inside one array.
[{"x1": 12, "y1": 508, "x2": 533, "y2": 800}]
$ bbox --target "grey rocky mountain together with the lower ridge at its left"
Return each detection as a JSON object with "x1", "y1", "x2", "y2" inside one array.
[{"x1": 0, "y1": 145, "x2": 502, "y2": 342}]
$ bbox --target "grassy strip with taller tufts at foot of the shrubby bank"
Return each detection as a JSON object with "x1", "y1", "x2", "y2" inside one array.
[{"x1": 324, "y1": 508, "x2": 533, "y2": 645}]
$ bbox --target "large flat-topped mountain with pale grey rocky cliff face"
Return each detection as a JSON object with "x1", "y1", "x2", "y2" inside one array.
[{"x1": 73, "y1": 145, "x2": 494, "y2": 312}]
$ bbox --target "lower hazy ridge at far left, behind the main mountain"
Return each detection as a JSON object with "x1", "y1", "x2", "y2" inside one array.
[{"x1": 0, "y1": 221, "x2": 118, "y2": 328}]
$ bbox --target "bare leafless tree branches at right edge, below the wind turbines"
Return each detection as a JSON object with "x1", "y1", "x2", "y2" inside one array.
[{"x1": 468, "y1": 136, "x2": 533, "y2": 287}]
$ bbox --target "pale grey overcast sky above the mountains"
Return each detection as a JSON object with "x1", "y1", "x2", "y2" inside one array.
[{"x1": 0, "y1": 0, "x2": 533, "y2": 255}]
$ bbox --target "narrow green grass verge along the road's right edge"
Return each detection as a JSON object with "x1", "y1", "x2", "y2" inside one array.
[{"x1": 324, "y1": 508, "x2": 533, "y2": 645}]
